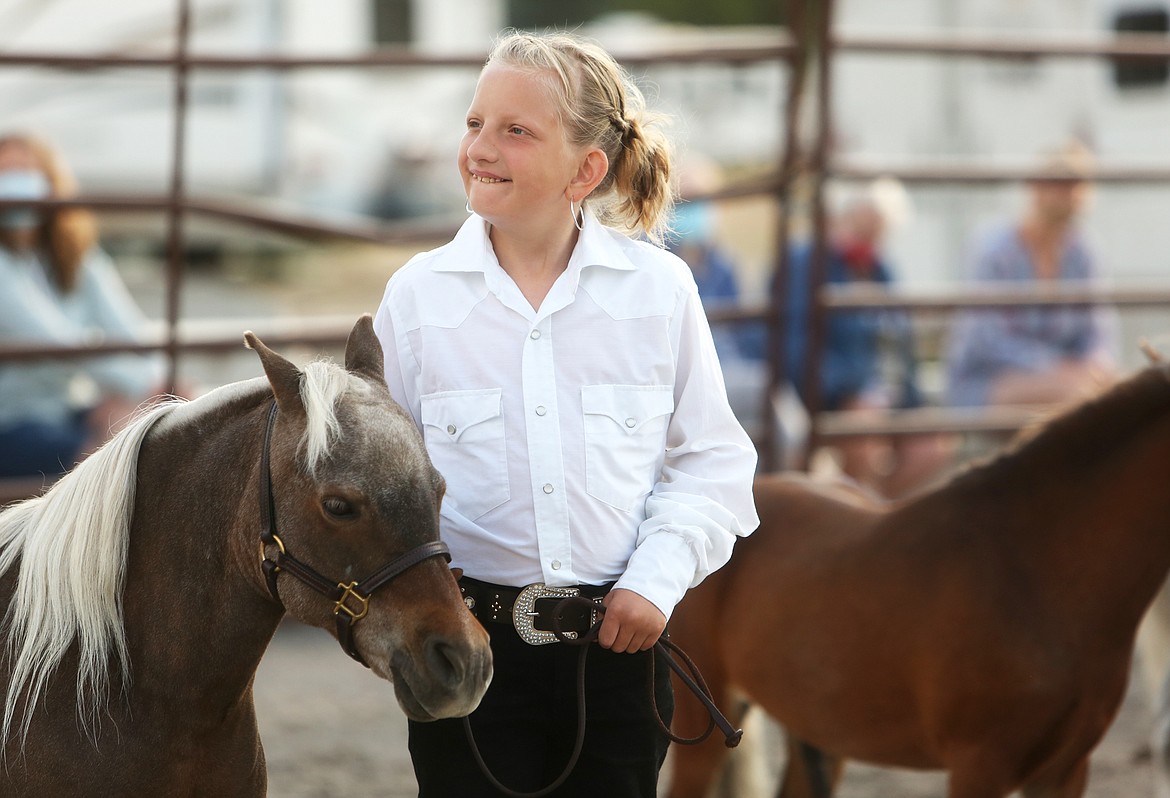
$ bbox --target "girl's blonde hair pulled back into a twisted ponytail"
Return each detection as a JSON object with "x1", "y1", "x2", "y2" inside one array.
[{"x1": 486, "y1": 30, "x2": 674, "y2": 243}]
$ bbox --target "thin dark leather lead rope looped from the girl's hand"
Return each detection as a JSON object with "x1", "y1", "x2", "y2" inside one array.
[{"x1": 463, "y1": 596, "x2": 743, "y2": 798}]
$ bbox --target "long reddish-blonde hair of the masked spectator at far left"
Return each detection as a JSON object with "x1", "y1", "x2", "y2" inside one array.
[{"x1": 0, "y1": 133, "x2": 97, "y2": 294}]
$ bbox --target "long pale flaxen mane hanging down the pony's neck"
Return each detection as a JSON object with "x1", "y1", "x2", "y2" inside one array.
[{"x1": 0, "y1": 400, "x2": 178, "y2": 748}]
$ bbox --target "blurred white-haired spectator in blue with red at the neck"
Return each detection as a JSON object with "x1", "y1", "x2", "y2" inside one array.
[{"x1": 756, "y1": 179, "x2": 951, "y2": 497}]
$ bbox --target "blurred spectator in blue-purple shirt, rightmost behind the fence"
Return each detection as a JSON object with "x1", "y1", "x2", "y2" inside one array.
[{"x1": 948, "y1": 144, "x2": 1116, "y2": 406}]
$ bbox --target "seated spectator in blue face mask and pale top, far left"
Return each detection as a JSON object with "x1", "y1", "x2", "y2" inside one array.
[{"x1": 0, "y1": 135, "x2": 161, "y2": 479}]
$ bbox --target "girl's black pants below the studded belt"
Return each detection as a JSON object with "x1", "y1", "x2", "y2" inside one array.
[{"x1": 410, "y1": 624, "x2": 674, "y2": 798}]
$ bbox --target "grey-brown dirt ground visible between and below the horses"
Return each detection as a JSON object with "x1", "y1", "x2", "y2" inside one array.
[{"x1": 255, "y1": 622, "x2": 1154, "y2": 798}]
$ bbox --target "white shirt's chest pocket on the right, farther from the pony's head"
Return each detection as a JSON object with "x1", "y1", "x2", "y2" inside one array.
[{"x1": 581, "y1": 385, "x2": 674, "y2": 512}]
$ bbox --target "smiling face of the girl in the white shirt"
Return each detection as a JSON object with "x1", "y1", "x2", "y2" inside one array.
[{"x1": 459, "y1": 64, "x2": 584, "y2": 236}]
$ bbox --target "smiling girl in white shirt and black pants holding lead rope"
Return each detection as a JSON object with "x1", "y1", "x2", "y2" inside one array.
[{"x1": 374, "y1": 33, "x2": 757, "y2": 798}]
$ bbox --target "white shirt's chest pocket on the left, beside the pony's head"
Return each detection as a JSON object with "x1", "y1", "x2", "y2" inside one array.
[{"x1": 421, "y1": 388, "x2": 510, "y2": 520}]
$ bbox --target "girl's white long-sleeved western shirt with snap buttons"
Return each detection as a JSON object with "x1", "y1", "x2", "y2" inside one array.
[{"x1": 374, "y1": 215, "x2": 758, "y2": 618}]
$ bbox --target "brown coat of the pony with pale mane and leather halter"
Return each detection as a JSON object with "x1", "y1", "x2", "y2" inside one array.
[{"x1": 0, "y1": 317, "x2": 491, "y2": 798}]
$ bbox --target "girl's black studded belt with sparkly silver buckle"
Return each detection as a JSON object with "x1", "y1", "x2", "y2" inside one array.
[{"x1": 459, "y1": 577, "x2": 612, "y2": 646}]
